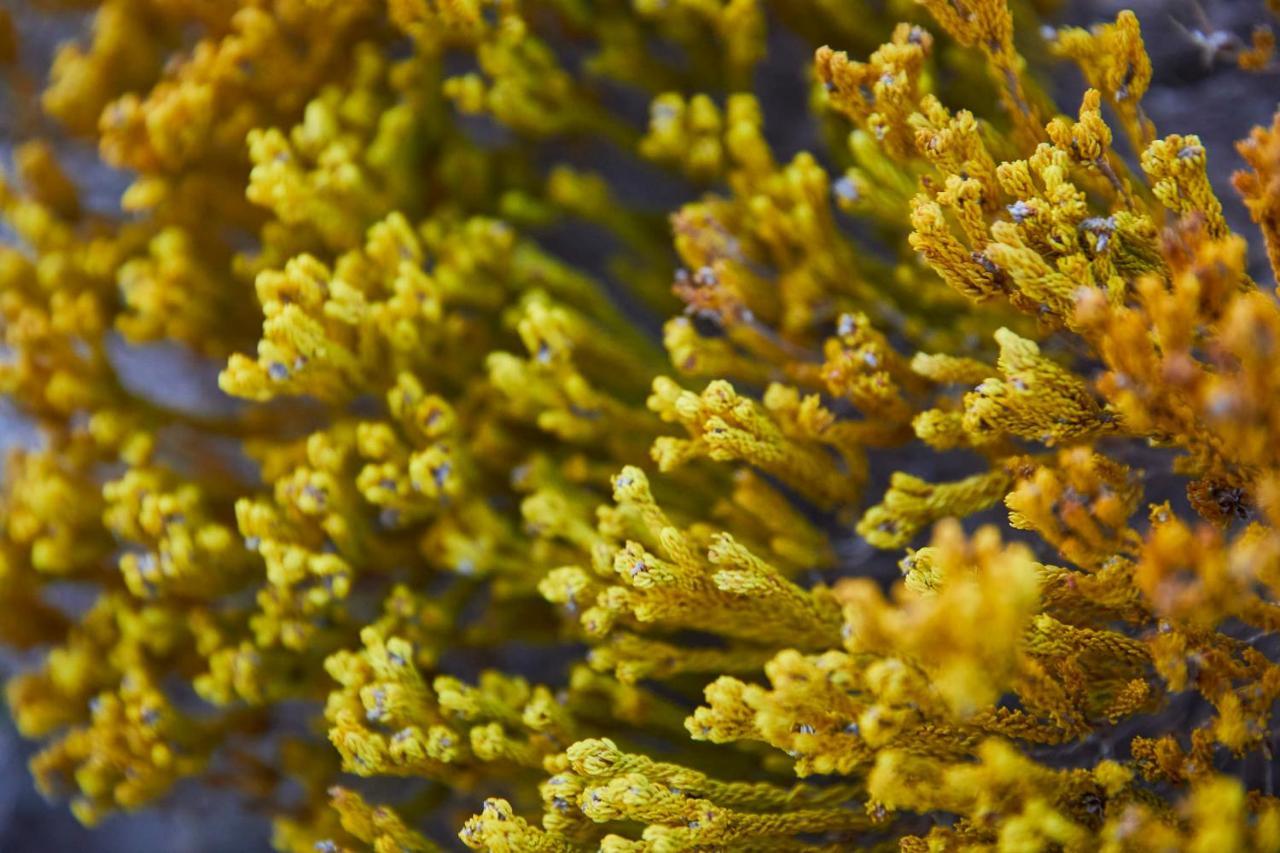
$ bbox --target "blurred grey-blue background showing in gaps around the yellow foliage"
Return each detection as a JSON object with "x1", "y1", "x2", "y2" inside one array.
[{"x1": 0, "y1": 0, "x2": 1280, "y2": 853}]
